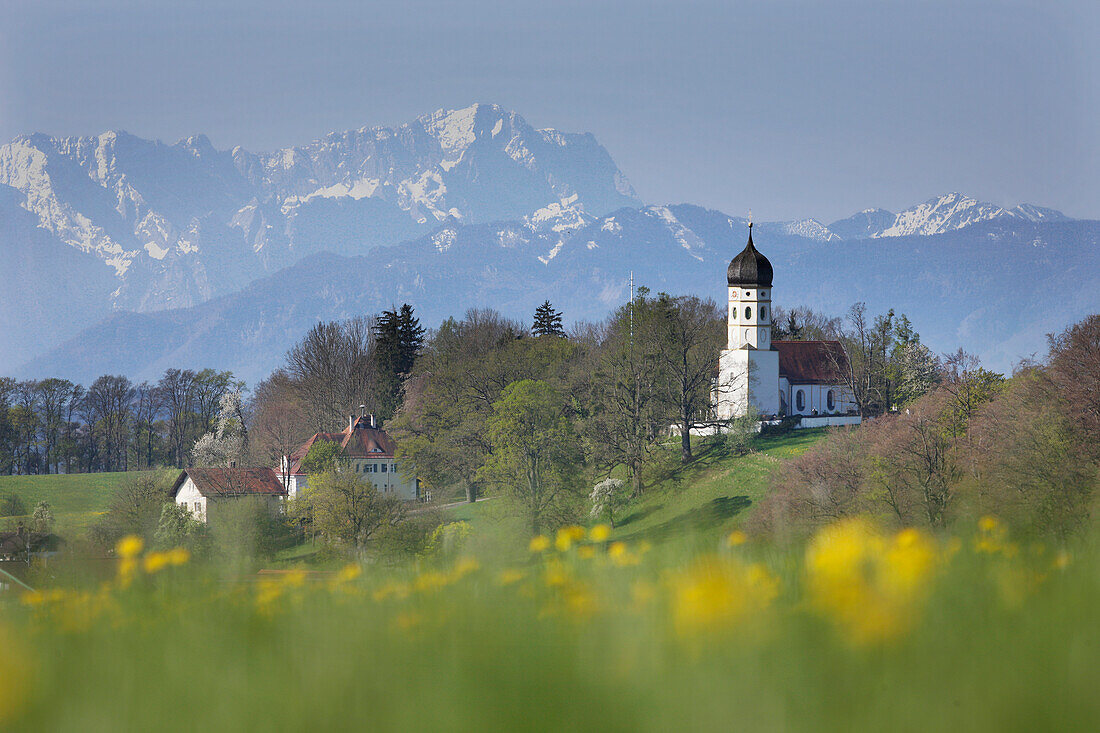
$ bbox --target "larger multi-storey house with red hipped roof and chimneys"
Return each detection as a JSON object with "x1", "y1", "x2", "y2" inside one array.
[{"x1": 276, "y1": 415, "x2": 431, "y2": 501}]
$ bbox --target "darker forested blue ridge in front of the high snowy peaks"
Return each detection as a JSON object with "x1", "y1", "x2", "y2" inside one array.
[{"x1": 23, "y1": 205, "x2": 1100, "y2": 382}]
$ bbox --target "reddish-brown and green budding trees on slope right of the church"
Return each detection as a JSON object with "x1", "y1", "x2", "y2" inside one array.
[{"x1": 755, "y1": 315, "x2": 1100, "y2": 537}]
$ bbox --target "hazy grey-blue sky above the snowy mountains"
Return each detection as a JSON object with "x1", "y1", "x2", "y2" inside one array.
[{"x1": 0, "y1": 0, "x2": 1100, "y2": 222}]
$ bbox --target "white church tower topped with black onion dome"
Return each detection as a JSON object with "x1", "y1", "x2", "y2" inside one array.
[{"x1": 717, "y1": 223, "x2": 779, "y2": 419}]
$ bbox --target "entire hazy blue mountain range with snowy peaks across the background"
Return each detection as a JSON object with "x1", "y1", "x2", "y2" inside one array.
[{"x1": 0, "y1": 105, "x2": 1100, "y2": 382}]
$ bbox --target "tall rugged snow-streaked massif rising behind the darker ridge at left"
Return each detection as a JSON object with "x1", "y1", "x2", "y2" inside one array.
[{"x1": 0, "y1": 105, "x2": 638, "y2": 311}]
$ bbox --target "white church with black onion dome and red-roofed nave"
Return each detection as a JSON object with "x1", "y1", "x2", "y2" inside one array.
[{"x1": 716, "y1": 223, "x2": 860, "y2": 427}]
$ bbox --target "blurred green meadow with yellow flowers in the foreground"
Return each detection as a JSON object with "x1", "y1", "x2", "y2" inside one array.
[{"x1": 0, "y1": 512, "x2": 1100, "y2": 731}]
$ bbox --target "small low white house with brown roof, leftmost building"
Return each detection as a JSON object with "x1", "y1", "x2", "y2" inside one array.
[{"x1": 172, "y1": 467, "x2": 286, "y2": 522}]
